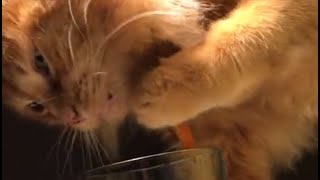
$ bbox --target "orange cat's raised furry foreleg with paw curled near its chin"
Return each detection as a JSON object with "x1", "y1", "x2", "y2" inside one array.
[{"x1": 135, "y1": 0, "x2": 317, "y2": 128}]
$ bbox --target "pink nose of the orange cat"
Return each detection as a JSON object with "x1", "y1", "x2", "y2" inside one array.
[{"x1": 61, "y1": 106, "x2": 83, "y2": 126}]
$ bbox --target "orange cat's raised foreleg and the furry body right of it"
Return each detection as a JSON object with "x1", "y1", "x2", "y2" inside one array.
[{"x1": 135, "y1": 0, "x2": 318, "y2": 180}]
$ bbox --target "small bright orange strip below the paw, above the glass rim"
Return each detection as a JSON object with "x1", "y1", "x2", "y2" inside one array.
[{"x1": 175, "y1": 123, "x2": 195, "y2": 149}]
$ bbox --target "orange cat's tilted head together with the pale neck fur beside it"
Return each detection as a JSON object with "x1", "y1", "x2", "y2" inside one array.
[{"x1": 2, "y1": 0, "x2": 215, "y2": 129}]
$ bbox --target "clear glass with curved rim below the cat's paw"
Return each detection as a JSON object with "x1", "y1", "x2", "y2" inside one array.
[{"x1": 84, "y1": 149, "x2": 226, "y2": 180}]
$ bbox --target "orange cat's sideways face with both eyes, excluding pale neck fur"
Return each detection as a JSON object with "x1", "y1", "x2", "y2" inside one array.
[{"x1": 2, "y1": 0, "x2": 151, "y2": 130}]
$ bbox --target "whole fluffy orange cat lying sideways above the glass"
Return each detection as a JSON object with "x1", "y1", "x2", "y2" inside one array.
[{"x1": 2, "y1": 0, "x2": 318, "y2": 180}]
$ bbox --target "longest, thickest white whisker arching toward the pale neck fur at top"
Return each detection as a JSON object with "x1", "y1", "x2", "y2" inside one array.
[{"x1": 95, "y1": 11, "x2": 181, "y2": 57}]
